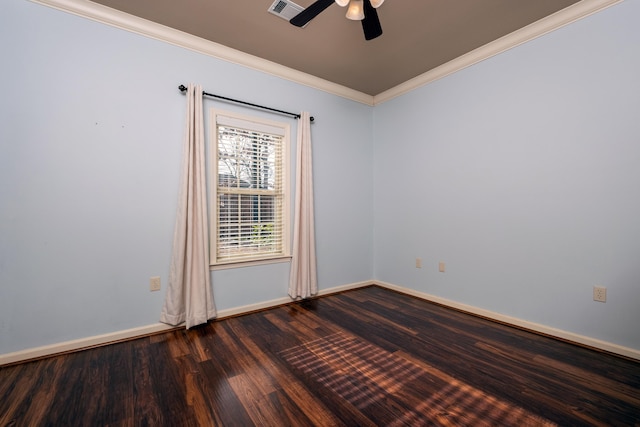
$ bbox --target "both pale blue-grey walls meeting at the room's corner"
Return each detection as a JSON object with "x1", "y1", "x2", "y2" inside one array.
[{"x1": 0, "y1": 0, "x2": 640, "y2": 354}]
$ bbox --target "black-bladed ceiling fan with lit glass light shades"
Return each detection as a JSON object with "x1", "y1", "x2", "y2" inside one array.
[{"x1": 289, "y1": 0, "x2": 384, "y2": 40}]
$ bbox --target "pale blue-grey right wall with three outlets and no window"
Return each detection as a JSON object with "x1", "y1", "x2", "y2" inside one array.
[{"x1": 374, "y1": 1, "x2": 640, "y2": 349}]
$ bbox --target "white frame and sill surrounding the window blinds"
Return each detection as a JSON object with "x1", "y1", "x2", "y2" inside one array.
[{"x1": 208, "y1": 107, "x2": 292, "y2": 270}]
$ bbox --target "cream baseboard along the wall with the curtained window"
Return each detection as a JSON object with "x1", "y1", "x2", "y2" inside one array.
[{"x1": 0, "y1": 281, "x2": 374, "y2": 366}]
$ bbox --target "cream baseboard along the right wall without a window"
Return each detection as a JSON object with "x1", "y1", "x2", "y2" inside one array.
[{"x1": 373, "y1": 281, "x2": 640, "y2": 360}]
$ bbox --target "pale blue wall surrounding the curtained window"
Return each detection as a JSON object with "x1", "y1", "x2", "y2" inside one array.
[{"x1": 0, "y1": 0, "x2": 373, "y2": 354}]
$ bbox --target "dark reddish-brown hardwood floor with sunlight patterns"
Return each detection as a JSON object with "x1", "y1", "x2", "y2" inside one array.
[{"x1": 0, "y1": 286, "x2": 640, "y2": 426}]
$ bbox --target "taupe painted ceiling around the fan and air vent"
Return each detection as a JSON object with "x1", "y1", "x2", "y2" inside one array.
[{"x1": 87, "y1": 0, "x2": 578, "y2": 96}]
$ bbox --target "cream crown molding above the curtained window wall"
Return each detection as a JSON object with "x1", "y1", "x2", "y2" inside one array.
[{"x1": 30, "y1": 0, "x2": 373, "y2": 106}]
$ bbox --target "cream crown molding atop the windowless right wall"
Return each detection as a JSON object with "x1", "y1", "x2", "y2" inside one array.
[{"x1": 373, "y1": 0, "x2": 624, "y2": 105}]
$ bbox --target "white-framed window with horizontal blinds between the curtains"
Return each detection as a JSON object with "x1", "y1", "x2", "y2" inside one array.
[{"x1": 210, "y1": 110, "x2": 289, "y2": 264}]
